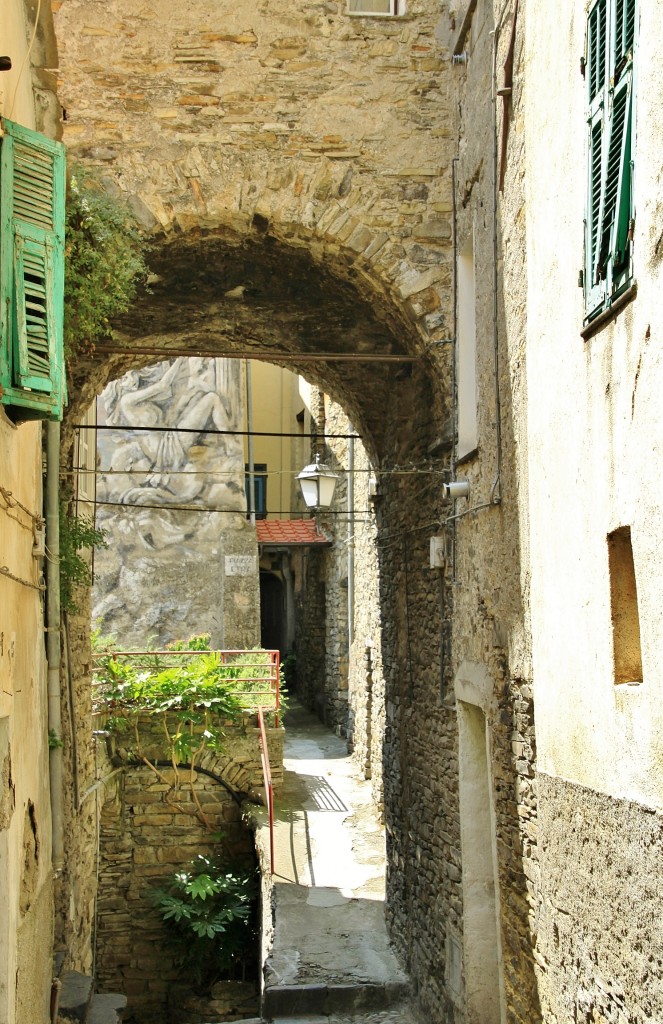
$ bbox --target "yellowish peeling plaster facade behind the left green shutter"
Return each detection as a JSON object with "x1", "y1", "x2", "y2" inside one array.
[{"x1": 0, "y1": 0, "x2": 59, "y2": 1024}]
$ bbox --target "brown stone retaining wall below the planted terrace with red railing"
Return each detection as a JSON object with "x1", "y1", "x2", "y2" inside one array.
[{"x1": 96, "y1": 721, "x2": 283, "y2": 1024}]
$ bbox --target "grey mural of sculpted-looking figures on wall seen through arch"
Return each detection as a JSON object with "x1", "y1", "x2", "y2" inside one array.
[{"x1": 93, "y1": 357, "x2": 259, "y2": 647}]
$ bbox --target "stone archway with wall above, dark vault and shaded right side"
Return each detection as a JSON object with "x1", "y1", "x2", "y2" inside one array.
[{"x1": 56, "y1": 0, "x2": 455, "y2": 1011}]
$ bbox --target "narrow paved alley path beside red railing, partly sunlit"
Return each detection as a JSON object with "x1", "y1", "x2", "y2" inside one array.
[{"x1": 252, "y1": 703, "x2": 419, "y2": 1024}]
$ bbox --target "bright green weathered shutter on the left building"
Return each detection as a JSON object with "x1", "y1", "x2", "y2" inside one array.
[{"x1": 0, "y1": 119, "x2": 66, "y2": 420}]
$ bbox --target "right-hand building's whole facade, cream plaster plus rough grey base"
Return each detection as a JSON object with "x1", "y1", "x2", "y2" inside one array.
[{"x1": 511, "y1": 2, "x2": 663, "y2": 1022}]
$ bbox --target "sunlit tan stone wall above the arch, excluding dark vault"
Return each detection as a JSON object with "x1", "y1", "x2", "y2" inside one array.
[{"x1": 55, "y1": 0, "x2": 451, "y2": 312}]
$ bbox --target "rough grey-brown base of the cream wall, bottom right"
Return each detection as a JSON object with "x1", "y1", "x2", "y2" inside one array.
[{"x1": 537, "y1": 772, "x2": 663, "y2": 1024}]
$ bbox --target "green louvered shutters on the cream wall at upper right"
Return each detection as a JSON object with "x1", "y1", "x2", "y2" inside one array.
[{"x1": 584, "y1": 0, "x2": 636, "y2": 322}]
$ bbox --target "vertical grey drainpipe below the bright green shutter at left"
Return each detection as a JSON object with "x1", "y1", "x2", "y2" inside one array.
[{"x1": 46, "y1": 423, "x2": 65, "y2": 874}]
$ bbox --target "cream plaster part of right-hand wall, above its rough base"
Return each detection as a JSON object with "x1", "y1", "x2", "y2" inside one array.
[{"x1": 516, "y1": 0, "x2": 663, "y2": 808}]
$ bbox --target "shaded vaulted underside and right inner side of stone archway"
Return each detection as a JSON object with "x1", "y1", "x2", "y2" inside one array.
[{"x1": 64, "y1": 214, "x2": 454, "y2": 1015}]
